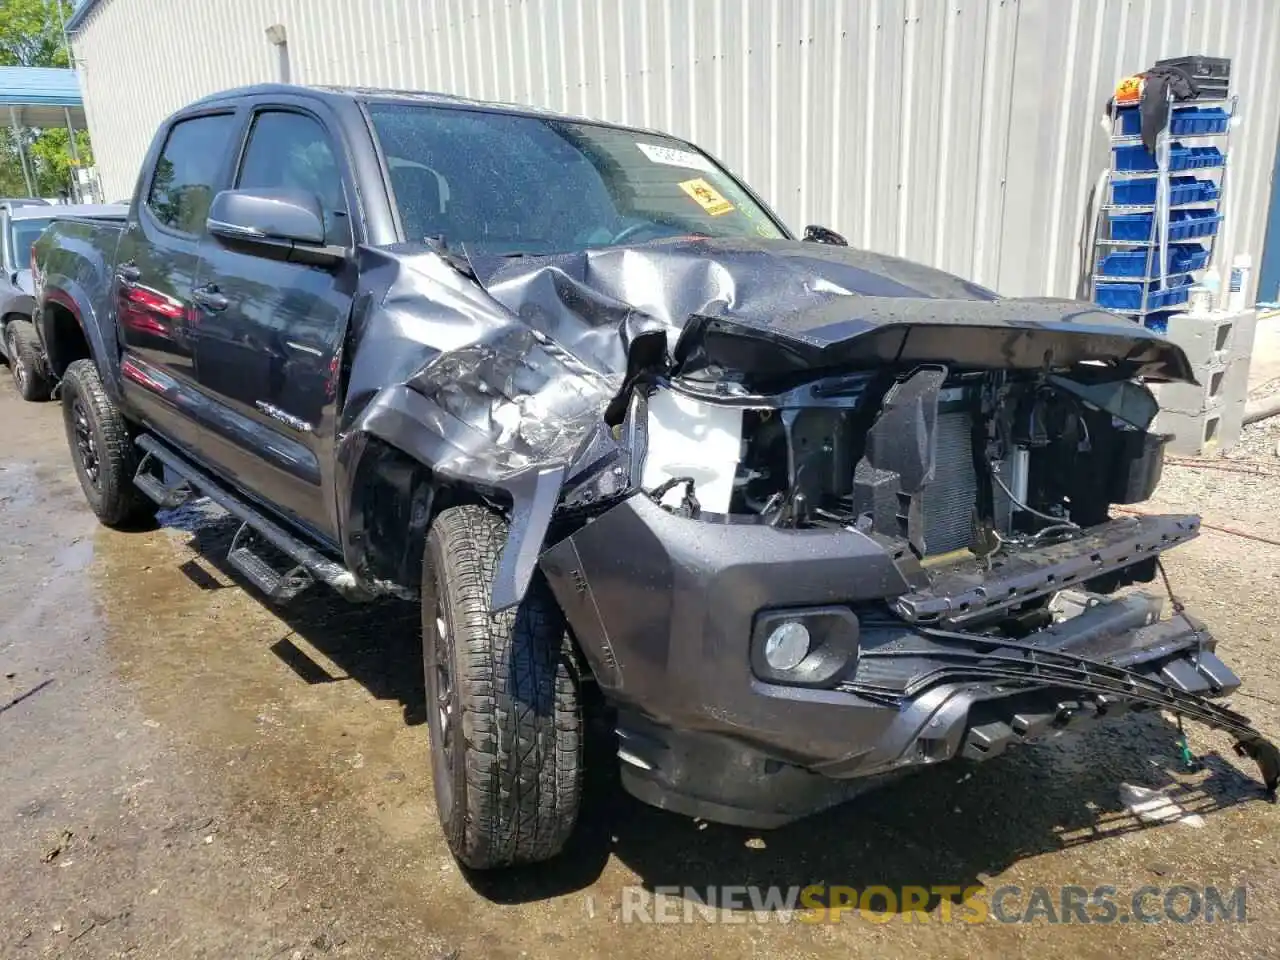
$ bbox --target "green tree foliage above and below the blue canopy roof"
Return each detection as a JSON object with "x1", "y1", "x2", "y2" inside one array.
[{"x1": 0, "y1": 0, "x2": 93, "y2": 196}]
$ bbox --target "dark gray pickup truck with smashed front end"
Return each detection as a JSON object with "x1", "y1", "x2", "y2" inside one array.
[{"x1": 36, "y1": 86, "x2": 1276, "y2": 868}]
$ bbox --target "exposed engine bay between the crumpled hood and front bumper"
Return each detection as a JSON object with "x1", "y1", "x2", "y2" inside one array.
[{"x1": 643, "y1": 366, "x2": 1167, "y2": 580}]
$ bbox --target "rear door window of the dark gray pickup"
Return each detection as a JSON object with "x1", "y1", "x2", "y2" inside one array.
[{"x1": 147, "y1": 114, "x2": 234, "y2": 233}]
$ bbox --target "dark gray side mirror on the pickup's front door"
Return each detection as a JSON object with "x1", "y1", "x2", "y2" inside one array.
[{"x1": 205, "y1": 189, "x2": 347, "y2": 266}]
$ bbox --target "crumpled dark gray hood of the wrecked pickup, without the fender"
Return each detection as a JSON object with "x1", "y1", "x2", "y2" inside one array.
[{"x1": 471, "y1": 239, "x2": 1190, "y2": 381}]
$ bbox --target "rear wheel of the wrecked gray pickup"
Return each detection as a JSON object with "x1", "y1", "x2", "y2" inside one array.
[{"x1": 63, "y1": 360, "x2": 155, "y2": 527}]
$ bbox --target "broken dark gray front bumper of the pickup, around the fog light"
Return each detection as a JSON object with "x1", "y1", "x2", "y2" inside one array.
[{"x1": 541, "y1": 495, "x2": 1251, "y2": 827}]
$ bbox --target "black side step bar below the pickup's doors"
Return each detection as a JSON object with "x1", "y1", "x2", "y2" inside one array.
[{"x1": 134, "y1": 434, "x2": 371, "y2": 600}]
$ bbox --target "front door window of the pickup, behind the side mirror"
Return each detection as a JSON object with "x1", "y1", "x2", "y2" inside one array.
[{"x1": 236, "y1": 110, "x2": 352, "y2": 247}]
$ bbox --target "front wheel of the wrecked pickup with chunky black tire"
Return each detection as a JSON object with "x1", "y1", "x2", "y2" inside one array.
[{"x1": 422, "y1": 504, "x2": 584, "y2": 870}]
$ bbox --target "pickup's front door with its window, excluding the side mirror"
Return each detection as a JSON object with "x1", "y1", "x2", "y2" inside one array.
[{"x1": 186, "y1": 102, "x2": 356, "y2": 541}]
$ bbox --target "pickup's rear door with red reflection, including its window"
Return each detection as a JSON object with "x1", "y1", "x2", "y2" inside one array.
[{"x1": 114, "y1": 109, "x2": 236, "y2": 451}]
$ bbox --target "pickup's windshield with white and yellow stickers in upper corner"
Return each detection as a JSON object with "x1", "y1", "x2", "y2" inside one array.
[{"x1": 369, "y1": 104, "x2": 783, "y2": 253}]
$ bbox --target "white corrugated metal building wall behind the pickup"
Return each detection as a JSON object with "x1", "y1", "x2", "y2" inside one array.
[{"x1": 64, "y1": 0, "x2": 1280, "y2": 302}]
